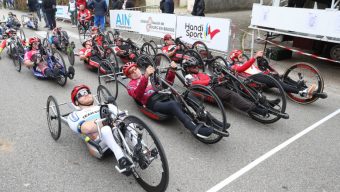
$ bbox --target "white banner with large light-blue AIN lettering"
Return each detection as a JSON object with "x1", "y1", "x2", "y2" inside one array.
[{"x1": 110, "y1": 10, "x2": 140, "y2": 32}]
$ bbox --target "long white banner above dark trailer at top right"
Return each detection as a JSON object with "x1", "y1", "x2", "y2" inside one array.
[{"x1": 251, "y1": 4, "x2": 340, "y2": 38}]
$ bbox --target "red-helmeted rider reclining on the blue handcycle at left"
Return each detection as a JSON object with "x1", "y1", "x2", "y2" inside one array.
[{"x1": 24, "y1": 37, "x2": 60, "y2": 77}]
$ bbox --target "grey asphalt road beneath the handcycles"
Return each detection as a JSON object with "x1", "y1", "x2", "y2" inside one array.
[{"x1": 0, "y1": 10, "x2": 340, "y2": 192}]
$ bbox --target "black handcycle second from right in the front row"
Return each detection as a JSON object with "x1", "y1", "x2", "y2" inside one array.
[{"x1": 208, "y1": 56, "x2": 289, "y2": 124}]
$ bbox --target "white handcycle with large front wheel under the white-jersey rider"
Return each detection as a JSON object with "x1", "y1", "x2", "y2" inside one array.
[{"x1": 46, "y1": 85, "x2": 169, "y2": 192}]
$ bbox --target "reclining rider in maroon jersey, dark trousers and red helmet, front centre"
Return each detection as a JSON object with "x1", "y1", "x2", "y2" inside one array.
[{"x1": 123, "y1": 62, "x2": 227, "y2": 137}]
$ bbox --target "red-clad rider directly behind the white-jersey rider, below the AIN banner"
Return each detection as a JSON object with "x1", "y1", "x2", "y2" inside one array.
[{"x1": 79, "y1": 38, "x2": 111, "y2": 74}]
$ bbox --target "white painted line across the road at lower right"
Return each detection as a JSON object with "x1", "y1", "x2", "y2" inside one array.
[{"x1": 207, "y1": 109, "x2": 340, "y2": 192}]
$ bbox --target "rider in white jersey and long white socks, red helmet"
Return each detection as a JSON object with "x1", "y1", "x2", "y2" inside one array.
[{"x1": 67, "y1": 84, "x2": 133, "y2": 170}]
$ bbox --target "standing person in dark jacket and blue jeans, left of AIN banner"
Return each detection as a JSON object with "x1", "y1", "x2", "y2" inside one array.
[{"x1": 89, "y1": 0, "x2": 107, "y2": 32}]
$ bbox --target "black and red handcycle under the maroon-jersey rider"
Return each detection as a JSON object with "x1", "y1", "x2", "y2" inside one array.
[{"x1": 101, "y1": 55, "x2": 229, "y2": 144}]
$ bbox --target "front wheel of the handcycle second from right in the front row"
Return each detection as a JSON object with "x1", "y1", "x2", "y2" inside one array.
[{"x1": 244, "y1": 74, "x2": 287, "y2": 124}]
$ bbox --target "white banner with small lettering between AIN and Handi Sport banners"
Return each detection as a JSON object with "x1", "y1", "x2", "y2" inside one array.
[{"x1": 138, "y1": 13, "x2": 176, "y2": 38}]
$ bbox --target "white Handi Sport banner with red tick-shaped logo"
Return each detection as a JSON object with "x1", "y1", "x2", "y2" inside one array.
[{"x1": 176, "y1": 16, "x2": 231, "y2": 51}]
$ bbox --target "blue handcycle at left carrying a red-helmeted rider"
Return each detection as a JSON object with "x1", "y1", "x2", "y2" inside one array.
[{"x1": 12, "y1": 41, "x2": 74, "y2": 86}]
